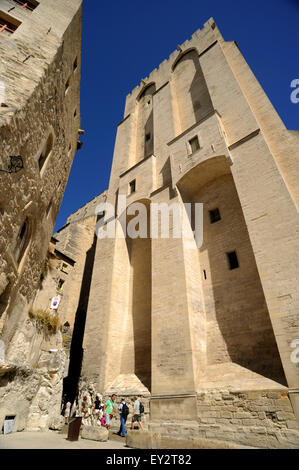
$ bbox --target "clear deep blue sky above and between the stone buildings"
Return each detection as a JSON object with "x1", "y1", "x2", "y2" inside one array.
[{"x1": 55, "y1": 0, "x2": 299, "y2": 230}]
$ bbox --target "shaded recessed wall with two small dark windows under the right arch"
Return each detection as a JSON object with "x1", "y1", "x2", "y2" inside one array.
[{"x1": 178, "y1": 158, "x2": 287, "y2": 385}]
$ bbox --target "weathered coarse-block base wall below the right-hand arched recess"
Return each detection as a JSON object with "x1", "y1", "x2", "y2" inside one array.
[{"x1": 197, "y1": 390, "x2": 299, "y2": 449}]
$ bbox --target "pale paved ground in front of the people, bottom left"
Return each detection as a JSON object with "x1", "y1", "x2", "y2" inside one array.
[{"x1": 0, "y1": 431, "x2": 129, "y2": 449}]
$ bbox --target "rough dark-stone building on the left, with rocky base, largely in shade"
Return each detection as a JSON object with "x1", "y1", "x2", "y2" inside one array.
[{"x1": 0, "y1": 0, "x2": 82, "y2": 431}]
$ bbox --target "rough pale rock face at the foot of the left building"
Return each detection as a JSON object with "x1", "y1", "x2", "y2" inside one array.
[{"x1": 0, "y1": 332, "x2": 66, "y2": 431}]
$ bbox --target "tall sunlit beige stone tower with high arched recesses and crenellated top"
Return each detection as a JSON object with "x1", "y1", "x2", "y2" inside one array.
[{"x1": 81, "y1": 19, "x2": 299, "y2": 447}]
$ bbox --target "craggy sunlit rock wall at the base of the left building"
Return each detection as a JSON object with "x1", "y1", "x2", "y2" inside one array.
[{"x1": 0, "y1": 319, "x2": 66, "y2": 432}]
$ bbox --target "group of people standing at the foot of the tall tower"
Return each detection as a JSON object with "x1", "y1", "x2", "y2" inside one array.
[{"x1": 62, "y1": 394, "x2": 144, "y2": 437}]
